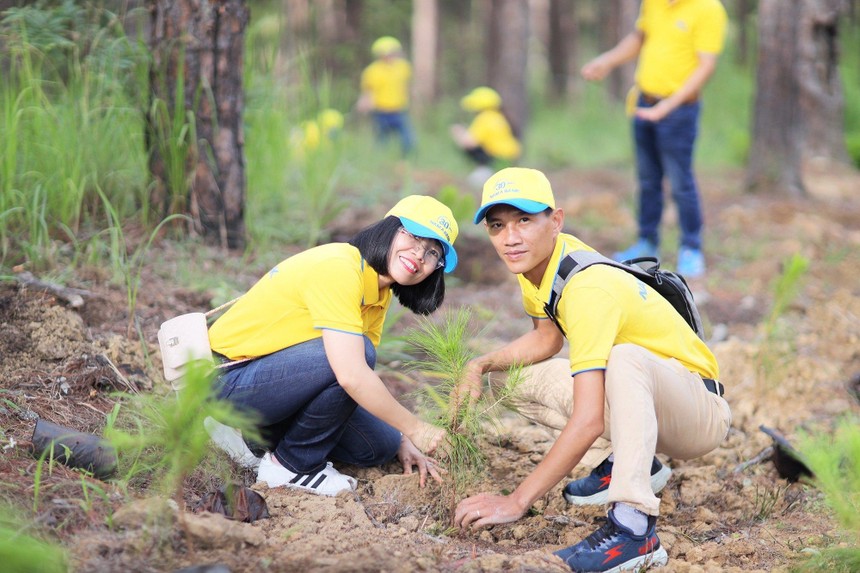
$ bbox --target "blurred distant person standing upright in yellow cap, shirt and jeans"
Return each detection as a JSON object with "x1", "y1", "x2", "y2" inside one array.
[{"x1": 356, "y1": 36, "x2": 415, "y2": 156}]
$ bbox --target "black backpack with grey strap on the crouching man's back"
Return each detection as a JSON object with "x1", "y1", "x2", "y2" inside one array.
[{"x1": 543, "y1": 251, "x2": 705, "y2": 340}]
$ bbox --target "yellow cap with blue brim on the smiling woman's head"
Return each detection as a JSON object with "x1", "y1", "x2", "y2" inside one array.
[{"x1": 385, "y1": 195, "x2": 460, "y2": 273}]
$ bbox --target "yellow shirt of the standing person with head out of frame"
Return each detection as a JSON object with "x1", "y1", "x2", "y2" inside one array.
[{"x1": 636, "y1": 0, "x2": 728, "y2": 97}]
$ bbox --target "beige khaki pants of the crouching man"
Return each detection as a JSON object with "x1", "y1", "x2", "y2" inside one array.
[{"x1": 490, "y1": 344, "x2": 732, "y2": 515}]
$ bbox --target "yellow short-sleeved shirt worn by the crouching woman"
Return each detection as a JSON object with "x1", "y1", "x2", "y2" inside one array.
[{"x1": 209, "y1": 243, "x2": 391, "y2": 360}]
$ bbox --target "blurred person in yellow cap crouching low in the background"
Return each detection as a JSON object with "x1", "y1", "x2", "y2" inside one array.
[{"x1": 451, "y1": 86, "x2": 522, "y2": 188}]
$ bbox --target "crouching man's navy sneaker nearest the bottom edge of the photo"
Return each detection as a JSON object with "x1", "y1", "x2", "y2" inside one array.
[{"x1": 555, "y1": 510, "x2": 669, "y2": 573}]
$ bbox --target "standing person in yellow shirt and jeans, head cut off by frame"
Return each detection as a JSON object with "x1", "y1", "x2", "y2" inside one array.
[{"x1": 582, "y1": 0, "x2": 727, "y2": 278}]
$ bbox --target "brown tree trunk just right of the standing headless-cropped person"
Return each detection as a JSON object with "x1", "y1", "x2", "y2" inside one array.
[{"x1": 746, "y1": 0, "x2": 805, "y2": 195}]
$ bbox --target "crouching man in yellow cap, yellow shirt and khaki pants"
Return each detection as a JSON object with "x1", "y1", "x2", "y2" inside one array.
[{"x1": 454, "y1": 167, "x2": 732, "y2": 571}]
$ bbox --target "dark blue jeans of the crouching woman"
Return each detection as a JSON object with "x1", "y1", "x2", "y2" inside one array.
[{"x1": 217, "y1": 337, "x2": 400, "y2": 474}]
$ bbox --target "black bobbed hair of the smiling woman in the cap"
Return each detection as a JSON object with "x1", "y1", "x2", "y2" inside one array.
[{"x1": 349, "y1": 216, "x2": 445, "y2": 315}]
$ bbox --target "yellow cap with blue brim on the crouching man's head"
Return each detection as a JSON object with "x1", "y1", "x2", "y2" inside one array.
[{"x1": 475, "y1": 167, "x2": 555, "y2": 225}]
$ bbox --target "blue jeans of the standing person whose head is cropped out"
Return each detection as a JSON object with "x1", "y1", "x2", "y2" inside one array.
[{"x1": 633, "y1": 96, "x2": 702, "y2": 250}]
